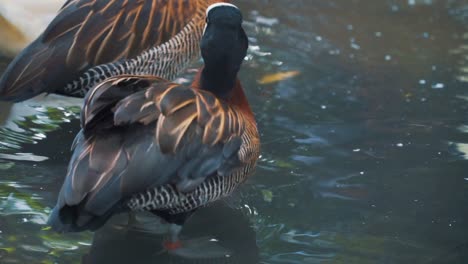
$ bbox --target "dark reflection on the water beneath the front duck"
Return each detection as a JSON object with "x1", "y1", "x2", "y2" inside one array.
[{"x1": 82, "y1": 202, "x2": 259, "y2": 264}]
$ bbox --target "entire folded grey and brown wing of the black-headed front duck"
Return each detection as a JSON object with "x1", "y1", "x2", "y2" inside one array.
[{"x1": 50, "y1": 77, "x2": 258, "y2": 231}]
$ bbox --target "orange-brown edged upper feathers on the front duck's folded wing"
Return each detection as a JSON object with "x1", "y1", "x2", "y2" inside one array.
[{"x1": 94, "y1": 77, "x2": 244, "y2": 153}]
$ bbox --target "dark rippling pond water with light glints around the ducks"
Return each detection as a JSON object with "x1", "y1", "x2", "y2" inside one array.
[{"x1": 0, "y1": 0, "x2": 468, "y2": 264}]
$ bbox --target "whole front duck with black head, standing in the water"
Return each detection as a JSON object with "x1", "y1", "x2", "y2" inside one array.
[{"x1": 48, "y1": 3, "x2": 260, "y2": 256}]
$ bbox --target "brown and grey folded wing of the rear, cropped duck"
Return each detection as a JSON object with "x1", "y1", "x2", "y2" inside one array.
[{"x1": 0, "y1": 0, "x2": 204, "y2": 101}]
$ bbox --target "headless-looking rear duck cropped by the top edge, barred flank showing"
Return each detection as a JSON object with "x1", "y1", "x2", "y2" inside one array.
[{"x1": 0, "y1": 0, "x2": 229, "y2": 102}]
